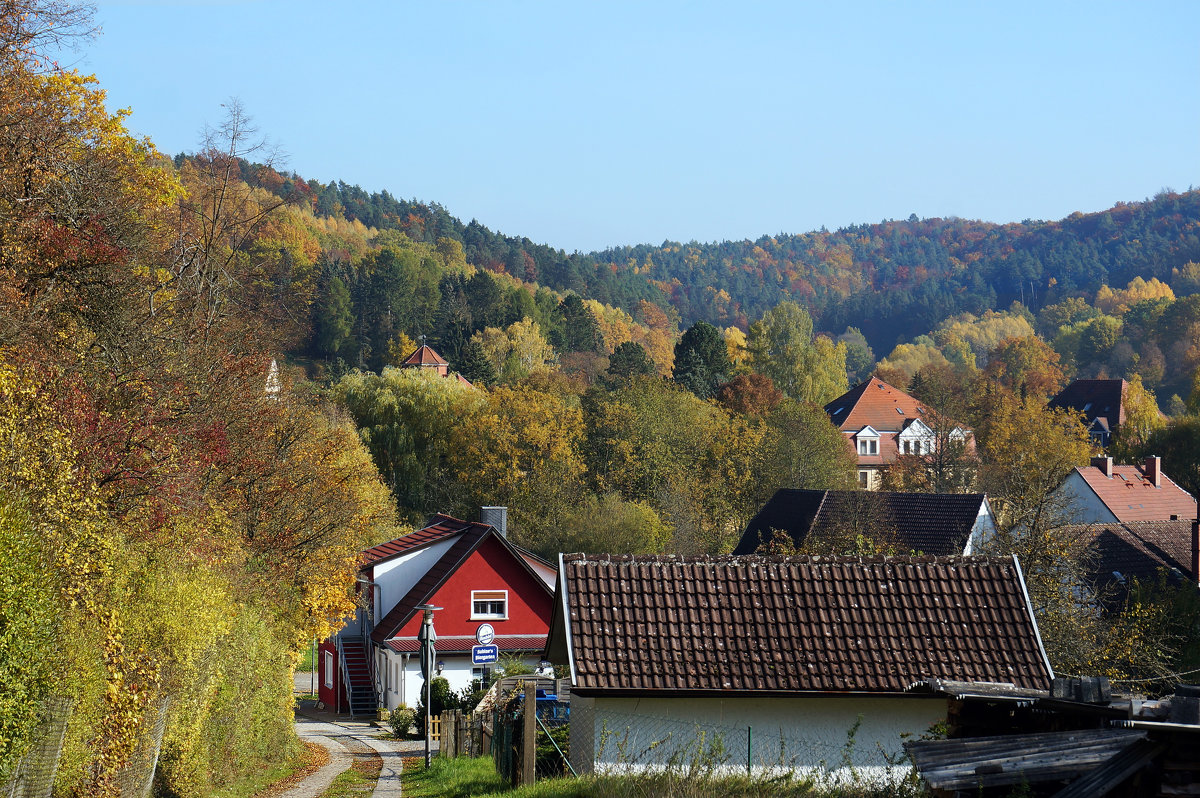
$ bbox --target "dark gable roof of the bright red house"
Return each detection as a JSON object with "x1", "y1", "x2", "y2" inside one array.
[{"x1": 371, "y1": 515, "x2": 552, "y2": 644}]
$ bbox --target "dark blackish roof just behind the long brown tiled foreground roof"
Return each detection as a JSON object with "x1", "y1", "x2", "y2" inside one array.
[{"x1": 733, "y1": 488, "x2": 986, "y2": 556}]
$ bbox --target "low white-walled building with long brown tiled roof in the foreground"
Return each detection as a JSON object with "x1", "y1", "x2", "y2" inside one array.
[{"x1": 547, "y1": 554, "x2": 1054, "y2": 780}]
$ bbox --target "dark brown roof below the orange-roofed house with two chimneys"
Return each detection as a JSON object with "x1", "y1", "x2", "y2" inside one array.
[{"x1": 1062, "y1": 518, "x2": 1192, "y2": 584}]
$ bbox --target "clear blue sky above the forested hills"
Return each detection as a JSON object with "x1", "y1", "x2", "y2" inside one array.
[{"x1": 76, "y1": 0, "x2": 1200, "y2": 251}]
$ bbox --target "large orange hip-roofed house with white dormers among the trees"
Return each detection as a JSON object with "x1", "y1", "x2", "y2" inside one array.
[{"x1": 824, "y1": 377, "x2": 971, "y2": 490}]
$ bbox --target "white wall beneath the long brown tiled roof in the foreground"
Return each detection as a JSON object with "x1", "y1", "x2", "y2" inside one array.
[{"x1": 570, "y1": 696, "x2": 947, "y2": 782}]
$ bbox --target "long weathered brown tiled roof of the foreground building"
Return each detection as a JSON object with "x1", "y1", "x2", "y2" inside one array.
[{"x1": 547, "y1": 554, "x2": 1054, "y2": 695}]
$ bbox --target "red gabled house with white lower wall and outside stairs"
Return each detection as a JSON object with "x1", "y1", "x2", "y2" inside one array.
[{"x1": 318, "y1": 508, "x2": 557, "y2": 715}]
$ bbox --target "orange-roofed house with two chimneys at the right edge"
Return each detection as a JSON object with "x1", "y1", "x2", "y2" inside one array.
[{"x1": 1058, "y1": 457, "x2": 1196, "y2": 523}]
